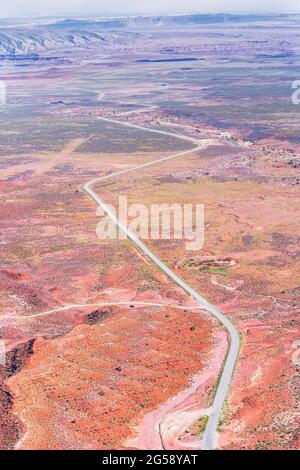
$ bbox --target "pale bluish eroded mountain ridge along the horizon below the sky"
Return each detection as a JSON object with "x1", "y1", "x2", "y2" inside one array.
[{"x1": 0, "y1": 14, "x2": 293, "y2": 56}]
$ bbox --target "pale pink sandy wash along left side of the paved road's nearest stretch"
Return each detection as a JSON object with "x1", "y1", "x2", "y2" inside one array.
[{"x1": 127, "y1": 331, "x2": 228, "y2": 450}]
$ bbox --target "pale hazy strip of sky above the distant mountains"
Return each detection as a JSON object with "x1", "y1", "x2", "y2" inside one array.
[{"x1": 0, "y1": 0, "x2": 300, "y2": 18}]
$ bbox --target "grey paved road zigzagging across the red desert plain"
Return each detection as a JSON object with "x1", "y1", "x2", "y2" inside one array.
[{"x1": 83, "y1": 118, "x2": 240, "y2": 450}]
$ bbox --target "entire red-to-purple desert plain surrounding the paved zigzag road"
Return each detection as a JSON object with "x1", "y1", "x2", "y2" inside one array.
[{"x1": 0, "y1": 13, "x2": 300, "y2": 449}]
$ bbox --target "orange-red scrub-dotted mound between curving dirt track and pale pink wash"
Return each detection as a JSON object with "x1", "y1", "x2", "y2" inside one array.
[{"x1": 7, "y1": 307, "x2": 213, "y2": 449}]
